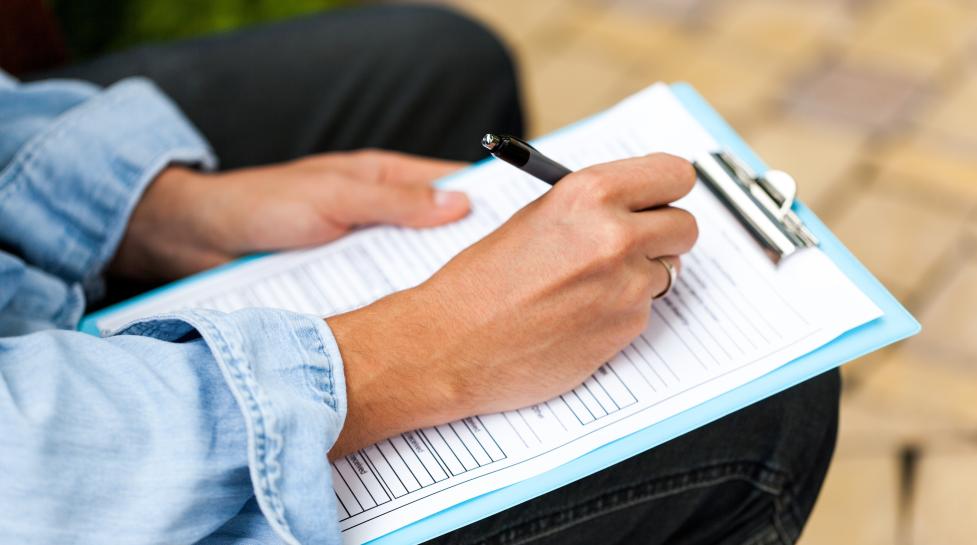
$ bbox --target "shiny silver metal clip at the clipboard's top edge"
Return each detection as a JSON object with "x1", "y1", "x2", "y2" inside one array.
[{"x1": 693, "y1": 151, "x2": 818, "y2": 263}]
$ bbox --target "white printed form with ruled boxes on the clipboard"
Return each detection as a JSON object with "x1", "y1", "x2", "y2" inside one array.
[{"x1": 98, "y1": 84, "x2": 881, "y2": 544}]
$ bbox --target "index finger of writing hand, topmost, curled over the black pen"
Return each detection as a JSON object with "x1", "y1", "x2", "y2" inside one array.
[{"x1": 580, "y1": 153, "x2": 696, "y2": 211}]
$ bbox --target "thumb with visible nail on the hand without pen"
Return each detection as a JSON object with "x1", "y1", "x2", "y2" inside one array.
[{"x1": 340, "y1": 183, "x2": 471, "y2": 227}]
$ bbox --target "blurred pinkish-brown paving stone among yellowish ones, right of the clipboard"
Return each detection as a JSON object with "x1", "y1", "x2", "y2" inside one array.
[{"x1": 785, "y1": 64, "x2": 926, "y2": 131}]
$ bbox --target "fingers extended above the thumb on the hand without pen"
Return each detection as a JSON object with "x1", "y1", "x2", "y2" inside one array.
[{"x1": 343, "y1": 150, "x2": 468, "y2": 185}]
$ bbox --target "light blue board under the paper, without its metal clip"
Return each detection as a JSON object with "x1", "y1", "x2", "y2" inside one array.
[{"x1": 79, "y1": 83, "x2": 920, "y2": 545}]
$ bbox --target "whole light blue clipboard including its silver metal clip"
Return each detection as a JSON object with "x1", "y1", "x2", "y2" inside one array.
[{"x1": 79, "y1": 83, "x2": 920, "y2": 545}]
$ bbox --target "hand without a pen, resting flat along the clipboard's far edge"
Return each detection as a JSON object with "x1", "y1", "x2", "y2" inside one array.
[{"x1": 110, "y1": 150, "x2": 469, "y2": 280}]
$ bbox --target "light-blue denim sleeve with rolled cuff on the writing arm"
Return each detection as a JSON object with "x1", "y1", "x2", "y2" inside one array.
[{"x1": 0, "y1": 309, "x2": 346, "y2": 544}]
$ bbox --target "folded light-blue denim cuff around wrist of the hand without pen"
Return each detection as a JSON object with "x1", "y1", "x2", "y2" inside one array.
[{"x1": 0, "y1": 78, "x2": 216, "y2": 285}]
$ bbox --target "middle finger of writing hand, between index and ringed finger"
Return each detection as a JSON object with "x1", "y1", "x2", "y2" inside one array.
[{"x1": 629, "y1": 206, "x2": 699, "y2": 258}]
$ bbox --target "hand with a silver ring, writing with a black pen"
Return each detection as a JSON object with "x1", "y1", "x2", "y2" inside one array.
[{"x1": 327, "y1": 154, "x2": 698, "y2": 458}]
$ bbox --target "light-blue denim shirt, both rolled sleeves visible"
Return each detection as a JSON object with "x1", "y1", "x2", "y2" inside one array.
[{"x1": 0, "y1": 72, "x2": 346, "y2": 544}]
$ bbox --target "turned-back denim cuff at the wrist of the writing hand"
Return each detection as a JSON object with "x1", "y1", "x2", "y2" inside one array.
[{"x1": 119, "y1": 309, "x2": 346, "y2": 544}]
